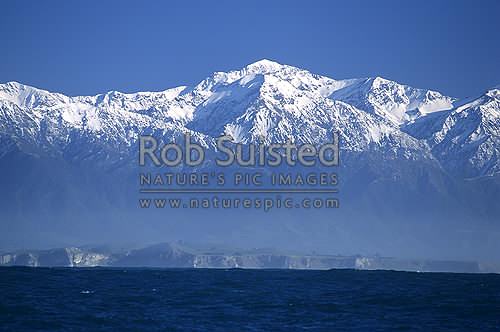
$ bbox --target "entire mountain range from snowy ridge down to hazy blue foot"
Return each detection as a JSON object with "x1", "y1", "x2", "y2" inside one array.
[{"x1": 0, "y1": 60, "x2": 500, "y2": 259}]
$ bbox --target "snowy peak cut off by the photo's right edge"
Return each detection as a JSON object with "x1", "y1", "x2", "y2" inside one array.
[{"x1": 403, "y1": 88, "x2": 500, "y2": 177}]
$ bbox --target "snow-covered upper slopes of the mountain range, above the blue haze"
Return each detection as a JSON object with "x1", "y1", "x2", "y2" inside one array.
[{"x1": 0, "y1": 60, "x2": 499, "y2": 176}]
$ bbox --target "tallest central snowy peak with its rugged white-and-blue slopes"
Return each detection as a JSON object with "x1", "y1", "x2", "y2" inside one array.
[{"x1": 183, "y1": 63, "x2": 418, "y2": 151}]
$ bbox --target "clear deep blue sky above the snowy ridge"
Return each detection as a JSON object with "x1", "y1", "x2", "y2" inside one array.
[{"x1": 0, "y1": 0, "x2": 500, "y2": 97}]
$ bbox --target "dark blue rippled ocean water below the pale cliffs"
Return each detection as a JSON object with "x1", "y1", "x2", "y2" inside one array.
[{"x1": 0, "y1": 267, "x2": 500, "y2": 331}]
